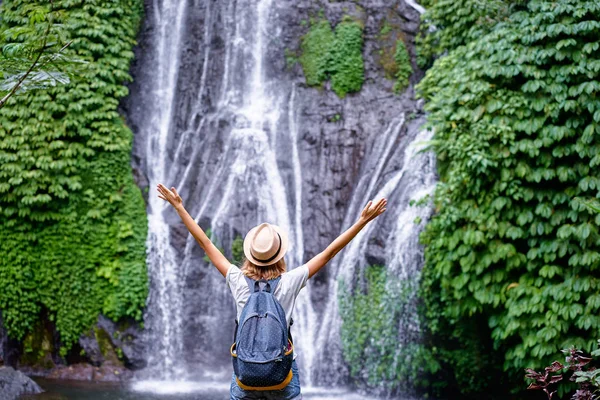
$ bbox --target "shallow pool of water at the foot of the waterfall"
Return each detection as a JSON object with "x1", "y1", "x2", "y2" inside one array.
[{"x1": 20, "y1": 379, "x2": 374, "y2": 400}]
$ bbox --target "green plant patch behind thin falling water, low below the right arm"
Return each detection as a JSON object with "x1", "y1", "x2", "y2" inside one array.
[{"x1": 338, "y1": 266, "x2": 439, "y2": 392}]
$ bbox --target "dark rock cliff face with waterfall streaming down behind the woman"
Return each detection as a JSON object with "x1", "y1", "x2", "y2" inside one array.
[{"x1": 123, "y1": 0, "x2": 434, "y2": 394}]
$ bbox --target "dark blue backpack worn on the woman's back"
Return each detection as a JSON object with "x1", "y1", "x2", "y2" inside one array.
[{"x1": 231, "y1": 277, "x2": 294, "y2": 390}]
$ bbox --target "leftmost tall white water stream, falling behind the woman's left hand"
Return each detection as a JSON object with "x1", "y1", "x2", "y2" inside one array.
[{"x1": 146, "y1": 0, "x2": 187, "y2": 380}]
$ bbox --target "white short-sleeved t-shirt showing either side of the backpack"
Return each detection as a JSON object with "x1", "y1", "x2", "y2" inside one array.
[{"x1": 225, "y1": 265, "x2": 308, "y2": 328}]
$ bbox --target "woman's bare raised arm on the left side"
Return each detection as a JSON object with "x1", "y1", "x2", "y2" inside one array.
[{"x1": 156, "y1": 183, "x2": 231, "y2": 276}]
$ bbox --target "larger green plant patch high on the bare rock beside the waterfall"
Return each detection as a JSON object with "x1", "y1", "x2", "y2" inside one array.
[{"x1": 299, "y1": 18, "x2": 364, "y2": 97}]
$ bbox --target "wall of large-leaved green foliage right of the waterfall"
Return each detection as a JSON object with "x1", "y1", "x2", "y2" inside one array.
[{"x1": 419, "y1": 0, "x2": 600, "y2": 393}]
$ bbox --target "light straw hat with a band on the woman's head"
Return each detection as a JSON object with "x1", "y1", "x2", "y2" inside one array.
[{"x1": 244, "y1": 223, "x2": 288, "y2": 267}]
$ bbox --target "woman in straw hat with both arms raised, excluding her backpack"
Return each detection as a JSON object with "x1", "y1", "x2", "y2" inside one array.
[{"x1": 157, "y1": 184, "x2": 387, "y2": 400}]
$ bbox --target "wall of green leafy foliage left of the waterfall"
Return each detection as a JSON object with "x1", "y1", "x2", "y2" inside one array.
[{"x1": 0, "y1": 0, "x2": 147, "y2": 354}]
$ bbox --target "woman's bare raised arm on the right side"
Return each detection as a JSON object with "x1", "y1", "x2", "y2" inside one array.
[{"x1": 306, "y1": 199, "x2": 387, "y2": 278}]
